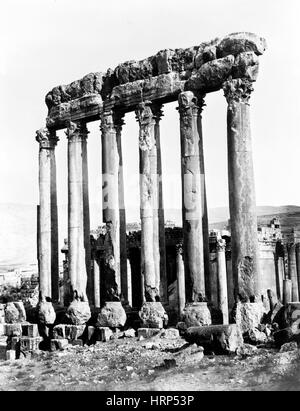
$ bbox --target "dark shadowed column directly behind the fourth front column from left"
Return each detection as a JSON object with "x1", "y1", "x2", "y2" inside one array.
[{"x1": 151, "y1": 105, "x2": 168, "y2": 303}]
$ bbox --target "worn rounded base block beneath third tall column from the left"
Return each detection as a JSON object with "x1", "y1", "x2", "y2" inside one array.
[{"x1": 97, "y1": 301, "x2": 127, "y2": 328}]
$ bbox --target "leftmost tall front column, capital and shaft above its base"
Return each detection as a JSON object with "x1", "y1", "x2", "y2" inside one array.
[{"x1": 36, "y1": 128, "x2": 59, "y2": 301}]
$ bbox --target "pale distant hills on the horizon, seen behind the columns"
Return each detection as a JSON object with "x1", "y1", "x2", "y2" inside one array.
[{"x1": 0, "y1": 203, "x2": 300, "y2": 271}]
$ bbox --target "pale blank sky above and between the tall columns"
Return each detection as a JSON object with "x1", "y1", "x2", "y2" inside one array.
[{"x1": 0, "y1": 0, "x2": 300, "y2": 224}]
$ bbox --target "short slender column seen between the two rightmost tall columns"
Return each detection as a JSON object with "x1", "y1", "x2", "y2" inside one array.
[{"x1": 217, "y1": 239, "x2": 229, "y2": 324}]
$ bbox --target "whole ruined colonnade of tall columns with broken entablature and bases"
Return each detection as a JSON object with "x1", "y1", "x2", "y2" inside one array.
[{"x1": 2, "y1": 32, "x2": 300, "y2": 360}]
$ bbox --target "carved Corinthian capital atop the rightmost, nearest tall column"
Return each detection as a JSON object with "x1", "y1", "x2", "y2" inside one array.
[{"x1": 223, "y1": 78, "x2": 254, "y2": 104}]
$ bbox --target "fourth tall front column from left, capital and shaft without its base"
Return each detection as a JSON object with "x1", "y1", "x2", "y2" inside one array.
[{"x1": 136, "y1": 103, "x2": 159, "y2": 301}]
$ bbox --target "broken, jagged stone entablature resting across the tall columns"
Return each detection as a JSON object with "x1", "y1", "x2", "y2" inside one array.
[{"x1": 46, "y1": 32, "x2": 266, "y2": 129}]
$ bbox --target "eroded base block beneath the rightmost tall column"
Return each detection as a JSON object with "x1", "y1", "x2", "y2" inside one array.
[{"x1": 235, "y1": 302, "x2": 266, "y2": 334}]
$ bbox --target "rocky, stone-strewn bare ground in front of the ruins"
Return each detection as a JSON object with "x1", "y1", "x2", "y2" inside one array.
[{"x1": 0, "y1": 336, "x2": 300, "y2": 391}]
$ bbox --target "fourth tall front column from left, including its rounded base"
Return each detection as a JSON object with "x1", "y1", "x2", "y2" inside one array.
[{"x1": 136, "y1": 102, "x2": 167, "y2": 328}]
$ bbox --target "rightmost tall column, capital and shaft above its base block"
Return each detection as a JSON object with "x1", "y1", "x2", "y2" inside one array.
[{"x1": 223, "y1": 79, "x2": 261, "y2": 301}]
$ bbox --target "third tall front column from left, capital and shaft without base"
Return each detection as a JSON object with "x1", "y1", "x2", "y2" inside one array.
[{"x1": 101, "y1": 111, "x2": 121, "y2": 301}]
